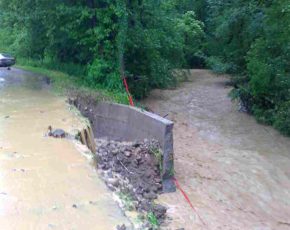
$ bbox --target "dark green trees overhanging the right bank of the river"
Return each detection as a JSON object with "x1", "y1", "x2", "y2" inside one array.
[{"x1": 205, "y1": 0, "x2": 290, "y2": 135}]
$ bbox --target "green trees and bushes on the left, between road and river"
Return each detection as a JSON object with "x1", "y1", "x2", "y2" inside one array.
[{"x1": 0, "y1": 0, "x2": 203, "y2": 98}]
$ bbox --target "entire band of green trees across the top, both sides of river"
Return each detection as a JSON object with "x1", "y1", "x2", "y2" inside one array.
[{"x1": 0, "y1": 0, "x2": 290, "y2": 135}]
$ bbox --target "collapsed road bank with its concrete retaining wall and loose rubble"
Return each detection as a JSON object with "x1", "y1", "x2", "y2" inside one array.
[{"x1": 68, "y1": 92, "x2": 175, "y2": 229}]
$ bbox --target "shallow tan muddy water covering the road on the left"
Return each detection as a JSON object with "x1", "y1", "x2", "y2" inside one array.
[{"x1": 0, "y1": 69, "x2": 128, "y2": 230}]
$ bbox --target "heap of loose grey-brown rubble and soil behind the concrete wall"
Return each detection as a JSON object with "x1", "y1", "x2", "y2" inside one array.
[{"x1": 96, "y1": 140, "x2": 166, "y2": 230}]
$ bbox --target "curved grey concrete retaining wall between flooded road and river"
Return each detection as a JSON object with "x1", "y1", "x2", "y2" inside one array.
[{"x1": 73, "y1": 98, "x2": 175, "y2": 192}]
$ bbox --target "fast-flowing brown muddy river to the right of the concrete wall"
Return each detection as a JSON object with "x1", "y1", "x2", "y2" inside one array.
[{"x1": 144, "y1": 70, "x2": 290, "y2": 230}]
